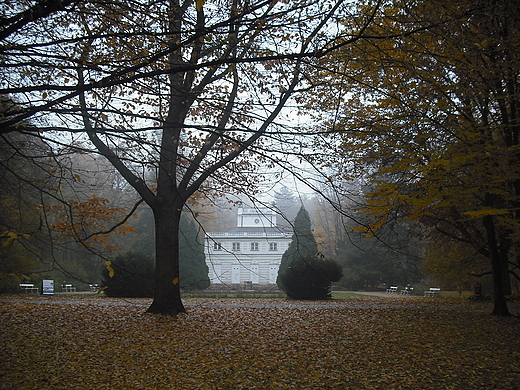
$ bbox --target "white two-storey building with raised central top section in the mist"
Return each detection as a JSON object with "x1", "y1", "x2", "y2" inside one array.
[{"x1": 204, "y1": 207, "x2": 292, "y2": 288}]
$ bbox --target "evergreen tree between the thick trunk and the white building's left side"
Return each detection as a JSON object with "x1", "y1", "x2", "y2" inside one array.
[{"x1": 179, "y1": 215, "x2": 209, "y2": 290}]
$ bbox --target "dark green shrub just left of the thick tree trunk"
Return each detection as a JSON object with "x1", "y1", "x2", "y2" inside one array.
[{"x1": 102, "y1": 252, "x2": 155, "y2": 298}]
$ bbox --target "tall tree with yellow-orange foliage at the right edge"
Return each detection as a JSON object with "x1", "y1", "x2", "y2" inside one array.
[{"x1": 312, "y1": 0, "x2": 520, "y2": 315}]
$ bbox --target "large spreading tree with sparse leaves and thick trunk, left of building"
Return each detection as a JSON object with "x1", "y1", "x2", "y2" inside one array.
[{"x1": 4, "y1": 0, "x2": 377, "y2": 315}]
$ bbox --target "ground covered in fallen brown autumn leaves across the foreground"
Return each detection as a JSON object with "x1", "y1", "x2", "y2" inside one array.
[{"x1": 0, "y1": 296, "x2": 520, "y2": 390}]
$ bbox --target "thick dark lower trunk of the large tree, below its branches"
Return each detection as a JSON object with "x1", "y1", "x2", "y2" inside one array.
[{"x1": 147, "y1": 206, "x2": 186, "y2": 317}]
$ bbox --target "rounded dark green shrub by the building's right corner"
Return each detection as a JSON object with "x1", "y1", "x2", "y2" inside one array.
[{"x1": 280, "y1": 257, "x2": 343, "y2": 300}]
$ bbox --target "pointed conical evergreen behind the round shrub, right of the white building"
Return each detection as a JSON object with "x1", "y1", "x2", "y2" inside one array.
[{"x1": 276, "y1": 205, "x2": 318, "y2": 291}]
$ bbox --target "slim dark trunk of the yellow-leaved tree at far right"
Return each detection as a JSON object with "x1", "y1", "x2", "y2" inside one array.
[{"x1": 483, "y1": 215, "x2": 511, "y2": 316}]
